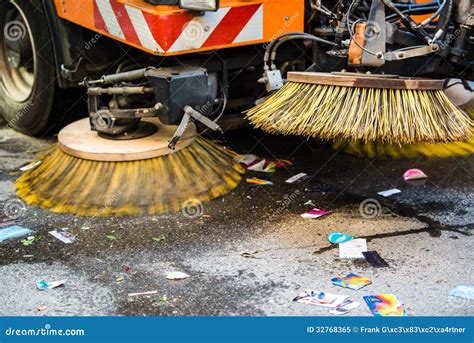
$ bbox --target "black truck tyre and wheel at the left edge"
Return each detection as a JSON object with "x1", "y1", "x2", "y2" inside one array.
[{"x1": 0, "y1": 0, "x2": 56, "y2": 136}]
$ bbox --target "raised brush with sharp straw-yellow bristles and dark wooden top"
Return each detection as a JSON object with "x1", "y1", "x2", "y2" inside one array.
[{"x1": 247, "y1": 72, "x2": 473, "y2": 143}]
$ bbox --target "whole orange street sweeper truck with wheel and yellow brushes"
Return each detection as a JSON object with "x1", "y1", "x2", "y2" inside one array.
[{"x1": 0, "y1": 0, "x2": 474, "y2": 216}]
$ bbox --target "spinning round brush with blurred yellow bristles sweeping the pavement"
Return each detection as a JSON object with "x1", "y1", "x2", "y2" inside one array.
[{"x1": 17, "y1": 119, "x2": 243, "y2": 217}]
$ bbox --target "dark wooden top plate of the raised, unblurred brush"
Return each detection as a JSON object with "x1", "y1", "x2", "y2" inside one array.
[{"x1": 288, "y1": 72, "x2": 444, "y2": 90}]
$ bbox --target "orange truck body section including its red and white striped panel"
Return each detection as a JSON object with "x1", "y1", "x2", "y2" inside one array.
[{"x1": 51, "y1": 0, "x2": 304, "y2": 56}]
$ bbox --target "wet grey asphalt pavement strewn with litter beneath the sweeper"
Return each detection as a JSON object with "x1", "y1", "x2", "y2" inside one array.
[{"x1": 0, "y1": 124, "x2": 474, "y2": 316}]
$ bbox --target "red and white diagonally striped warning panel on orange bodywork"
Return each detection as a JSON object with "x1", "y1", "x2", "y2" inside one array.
[{"x1": 94, "y1": 0, "x2": 263, "y2": 54}]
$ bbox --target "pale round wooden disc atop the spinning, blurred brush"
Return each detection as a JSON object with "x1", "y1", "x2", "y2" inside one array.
[{"x1": 58, "y1": 118, "x2": 196, "y2": 162}]
